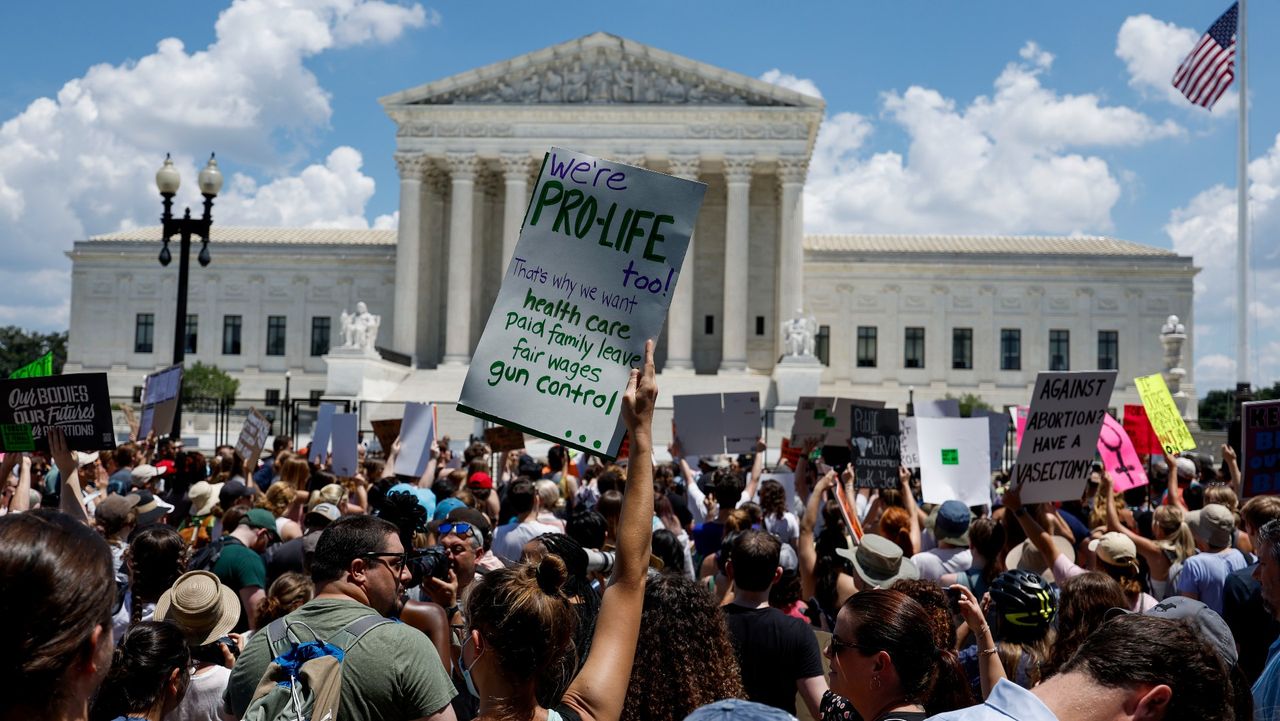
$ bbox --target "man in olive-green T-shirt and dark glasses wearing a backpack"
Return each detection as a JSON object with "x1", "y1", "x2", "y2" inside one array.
[{"x1": 223, "y1": 516, "x2": 456, "y2": 721}]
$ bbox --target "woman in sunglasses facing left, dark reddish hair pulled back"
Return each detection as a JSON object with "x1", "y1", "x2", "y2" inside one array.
[{"x1": 822, "y1": 589, "x2": 973, "y2": 721}]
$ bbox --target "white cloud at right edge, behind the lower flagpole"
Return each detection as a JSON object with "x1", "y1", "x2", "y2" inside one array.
[{"x1": 1165, "y1": 129, "x2": 1280, "y2": 393}]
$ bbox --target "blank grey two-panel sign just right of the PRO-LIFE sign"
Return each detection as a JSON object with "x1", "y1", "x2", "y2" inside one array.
[{"x1": 672, "y1": 392, "x2": 760, "y2": 456}]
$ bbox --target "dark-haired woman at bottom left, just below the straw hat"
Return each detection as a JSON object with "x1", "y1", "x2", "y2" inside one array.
[{"x1": 88, "y1": 621, "x2": 191, "y2": 721}]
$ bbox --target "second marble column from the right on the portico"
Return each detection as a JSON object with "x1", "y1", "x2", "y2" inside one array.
[{"x1": 719, "y1": 155, "x2": 755, "y2": 373}]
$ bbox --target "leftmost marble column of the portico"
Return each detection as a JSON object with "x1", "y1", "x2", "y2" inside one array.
[{"x1": 392, "y1": 154, "x2": 430, "y2": 361}]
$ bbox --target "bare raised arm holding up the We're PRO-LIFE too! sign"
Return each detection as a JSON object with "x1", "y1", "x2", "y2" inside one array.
[{"x1": 563, "y1": 341, "x2": 658, "y2": 721}]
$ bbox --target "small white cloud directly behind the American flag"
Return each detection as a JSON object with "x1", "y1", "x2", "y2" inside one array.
[{"x1": 1116, "y1": 14, "x2": 1238, "y2": 117}]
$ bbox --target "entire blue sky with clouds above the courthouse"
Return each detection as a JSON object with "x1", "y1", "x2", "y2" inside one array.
[{"x1": 0, "y1": 0, "x2": 1280, "y2": 392}]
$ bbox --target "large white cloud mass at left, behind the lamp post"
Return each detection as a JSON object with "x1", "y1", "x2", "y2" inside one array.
[{"x1": 0, "y1": 0, "x2": 439, "y2": 329}]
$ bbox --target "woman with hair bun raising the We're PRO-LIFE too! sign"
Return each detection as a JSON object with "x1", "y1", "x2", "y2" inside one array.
[{"x1": 460, "y1": 341, "x2": 658, "y2": 721}]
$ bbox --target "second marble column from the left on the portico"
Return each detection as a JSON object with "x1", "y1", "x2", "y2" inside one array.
[{"x1": 444, "y1": 152, "x2": 480, "y2": 365}]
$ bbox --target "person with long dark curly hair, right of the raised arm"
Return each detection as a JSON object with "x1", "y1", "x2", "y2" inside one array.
[{"x1": 621, "y1": 574, "x2": 745, "y2": 721}]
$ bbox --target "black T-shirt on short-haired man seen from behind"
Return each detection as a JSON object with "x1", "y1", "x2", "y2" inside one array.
[{"x1": 723, "y1": 603, "x2": 822, "y2": 716}]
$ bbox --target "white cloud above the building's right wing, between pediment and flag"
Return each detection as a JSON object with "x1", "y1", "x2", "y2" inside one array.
[{"x1": 805, "y1": 42, "x2": 1183, "y2": 233}]
